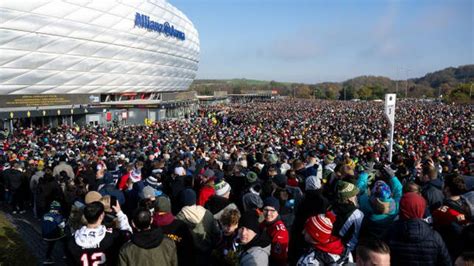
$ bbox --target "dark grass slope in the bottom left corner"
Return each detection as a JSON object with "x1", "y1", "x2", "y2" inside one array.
[{"x1": 0, "y1": 211, "x2": 36, "y2": 266}]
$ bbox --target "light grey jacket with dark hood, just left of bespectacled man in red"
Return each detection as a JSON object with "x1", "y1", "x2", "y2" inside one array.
[{"x1": 239, "y1": 232, "x2": 271, "y2": 266}]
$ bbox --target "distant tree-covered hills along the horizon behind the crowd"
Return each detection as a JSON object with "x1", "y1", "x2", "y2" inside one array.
[{"x1": 191, "y1": 65, "x2": 474, "y2": 100}]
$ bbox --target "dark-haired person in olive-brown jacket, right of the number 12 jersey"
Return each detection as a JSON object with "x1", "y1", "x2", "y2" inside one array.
[{"x1": 118, "y1": 208, "x2": 178, "y2": 266}]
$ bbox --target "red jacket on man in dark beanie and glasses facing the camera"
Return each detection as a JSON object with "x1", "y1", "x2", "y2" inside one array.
[{"x1": 260, "y1": 220, "x2": 290, "y2": 265}]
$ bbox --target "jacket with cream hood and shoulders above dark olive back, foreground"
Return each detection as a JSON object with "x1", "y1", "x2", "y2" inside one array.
[{"x1": 176, "y1": 205, "x2": 219, "y2": 256}]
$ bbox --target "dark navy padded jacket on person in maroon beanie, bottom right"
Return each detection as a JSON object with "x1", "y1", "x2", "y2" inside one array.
[{"x1": 387, "y1": 219, "x2": 452, "y2": 266}]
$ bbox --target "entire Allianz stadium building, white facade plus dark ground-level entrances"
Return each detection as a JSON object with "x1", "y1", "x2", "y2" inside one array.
[{"x1": 0, "y1": 0, "x2": 200, "y2": 127}]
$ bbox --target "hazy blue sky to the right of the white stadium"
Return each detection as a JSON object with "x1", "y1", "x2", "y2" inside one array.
[{"x1": 169, "y1": 0, "x2": 474, "y2": 83}]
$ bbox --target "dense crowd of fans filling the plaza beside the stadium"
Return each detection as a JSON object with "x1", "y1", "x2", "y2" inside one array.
[{"x1": 0, "y1": 100, "x2": 474, "y2": 266}]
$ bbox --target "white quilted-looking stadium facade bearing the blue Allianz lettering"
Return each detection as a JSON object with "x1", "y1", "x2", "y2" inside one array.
[{"x1": 0, "y1": 0, "x2": 200, "y2": 95}]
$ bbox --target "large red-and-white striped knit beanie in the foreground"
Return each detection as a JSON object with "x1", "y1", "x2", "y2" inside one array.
[{"x1": 304, "y1": 212, "x2": 336, "y2": 243}]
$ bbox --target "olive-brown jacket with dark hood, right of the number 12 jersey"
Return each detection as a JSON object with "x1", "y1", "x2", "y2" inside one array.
[{"x1": 118, "y1": 228, "x2": 178, "y2": 266}]
